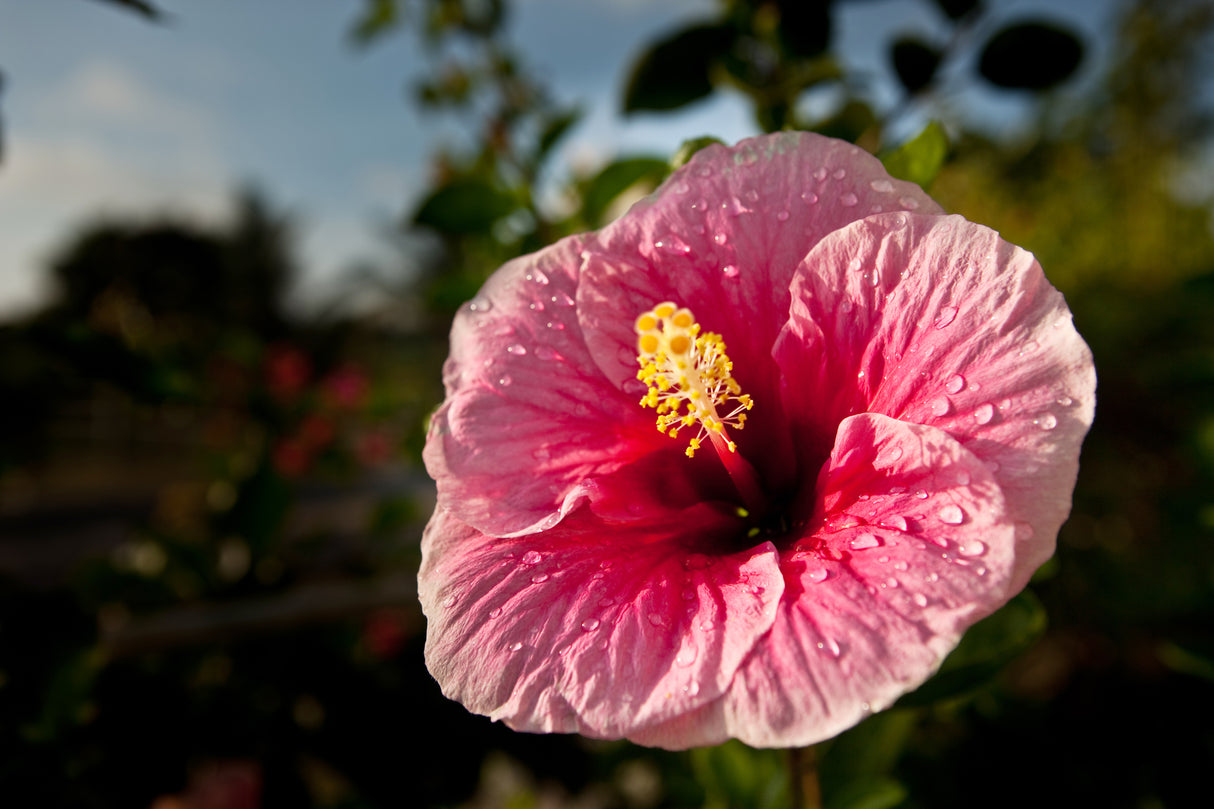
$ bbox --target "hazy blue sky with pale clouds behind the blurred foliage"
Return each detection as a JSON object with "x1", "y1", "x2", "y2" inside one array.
[{"x1": 0, "y1": 0, "x2": 1111, "y2": 317}]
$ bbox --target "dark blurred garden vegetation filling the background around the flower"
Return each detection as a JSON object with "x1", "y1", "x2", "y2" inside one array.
[{"x1": 0, "y1": 0, "x2": 1214, "y2": 809}]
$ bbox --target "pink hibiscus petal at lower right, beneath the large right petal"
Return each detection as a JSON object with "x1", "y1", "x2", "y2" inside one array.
[{"x1": 722, "y1": 413, "x2": 1015, "y2": 747}]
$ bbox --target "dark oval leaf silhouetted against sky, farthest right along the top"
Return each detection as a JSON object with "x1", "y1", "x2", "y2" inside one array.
[{"x1": 978, "y1": 22, "x2": 1083, "y2": 90}]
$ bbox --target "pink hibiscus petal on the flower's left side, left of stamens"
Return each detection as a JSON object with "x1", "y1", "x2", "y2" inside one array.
[{"x1": 425, "y1": 233, "x2": 687, "y2": 536}]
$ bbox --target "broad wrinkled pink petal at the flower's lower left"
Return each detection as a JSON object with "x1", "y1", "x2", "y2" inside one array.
[{"x1": 419, "y1": 505, "x2": 783, "y2": 739}]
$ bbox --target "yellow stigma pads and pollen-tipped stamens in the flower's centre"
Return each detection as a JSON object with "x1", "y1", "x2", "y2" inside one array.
[{"x1": 636, "y1": 302, "x2": 754, "y2": 458}]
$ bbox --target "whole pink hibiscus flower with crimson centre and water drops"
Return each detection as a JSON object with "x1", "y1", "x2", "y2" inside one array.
[{"x1": 420, "y1": 132, "x2": 1095, "y2": 748}]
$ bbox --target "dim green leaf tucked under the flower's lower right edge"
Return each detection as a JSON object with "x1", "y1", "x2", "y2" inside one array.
[{"x1": 897, "y1": 590, "x2": 1046, "y2": 707}]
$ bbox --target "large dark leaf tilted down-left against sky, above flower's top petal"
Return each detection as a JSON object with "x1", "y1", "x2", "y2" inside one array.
[{"x1": 624, "y1": 26, "x2": 736, "y2": 113}]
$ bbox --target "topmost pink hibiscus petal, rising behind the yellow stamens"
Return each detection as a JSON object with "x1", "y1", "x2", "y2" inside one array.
[{"x1": 578, "y1": 132, "x2": 940, "y2": 482}]
